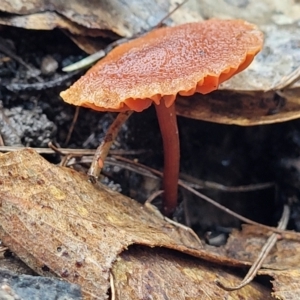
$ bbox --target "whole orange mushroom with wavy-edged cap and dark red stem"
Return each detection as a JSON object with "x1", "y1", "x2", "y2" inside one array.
[{"x1": 61, "y1": 19, "x2": 263, "y2": 215}]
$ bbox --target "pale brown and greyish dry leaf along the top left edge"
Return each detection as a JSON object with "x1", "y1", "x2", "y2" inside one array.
[{"x1": 0, "y1": 0, "x2": 170, "y2": 37}]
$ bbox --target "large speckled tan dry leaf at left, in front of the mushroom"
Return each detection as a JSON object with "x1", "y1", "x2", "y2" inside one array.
[{"x1": 0, "y1": 149, "x2": 251, "y2": 299}]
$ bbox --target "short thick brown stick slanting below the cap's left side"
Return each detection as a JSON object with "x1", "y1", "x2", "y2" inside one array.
[{"x1": 88, "y1": 111, "x2": 132, "y2": 183}]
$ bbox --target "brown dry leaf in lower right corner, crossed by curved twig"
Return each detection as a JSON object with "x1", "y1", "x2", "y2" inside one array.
[{"x1": 210, "y1": 225, "x2": 300, "y2": 300}]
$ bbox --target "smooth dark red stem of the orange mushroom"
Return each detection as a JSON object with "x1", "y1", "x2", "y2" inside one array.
[{"x1": 155, "y1": 99, "x2": 180, "y2": 216}]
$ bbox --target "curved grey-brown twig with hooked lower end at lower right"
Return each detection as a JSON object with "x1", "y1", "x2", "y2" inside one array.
[{"x1": 216, "y1": 205, "x2": 290, "y2": 291}]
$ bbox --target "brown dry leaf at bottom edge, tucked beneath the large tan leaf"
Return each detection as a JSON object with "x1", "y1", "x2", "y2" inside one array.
[{"x1": 112, "y1": 247, "x2": 273, "y2": 300}]
